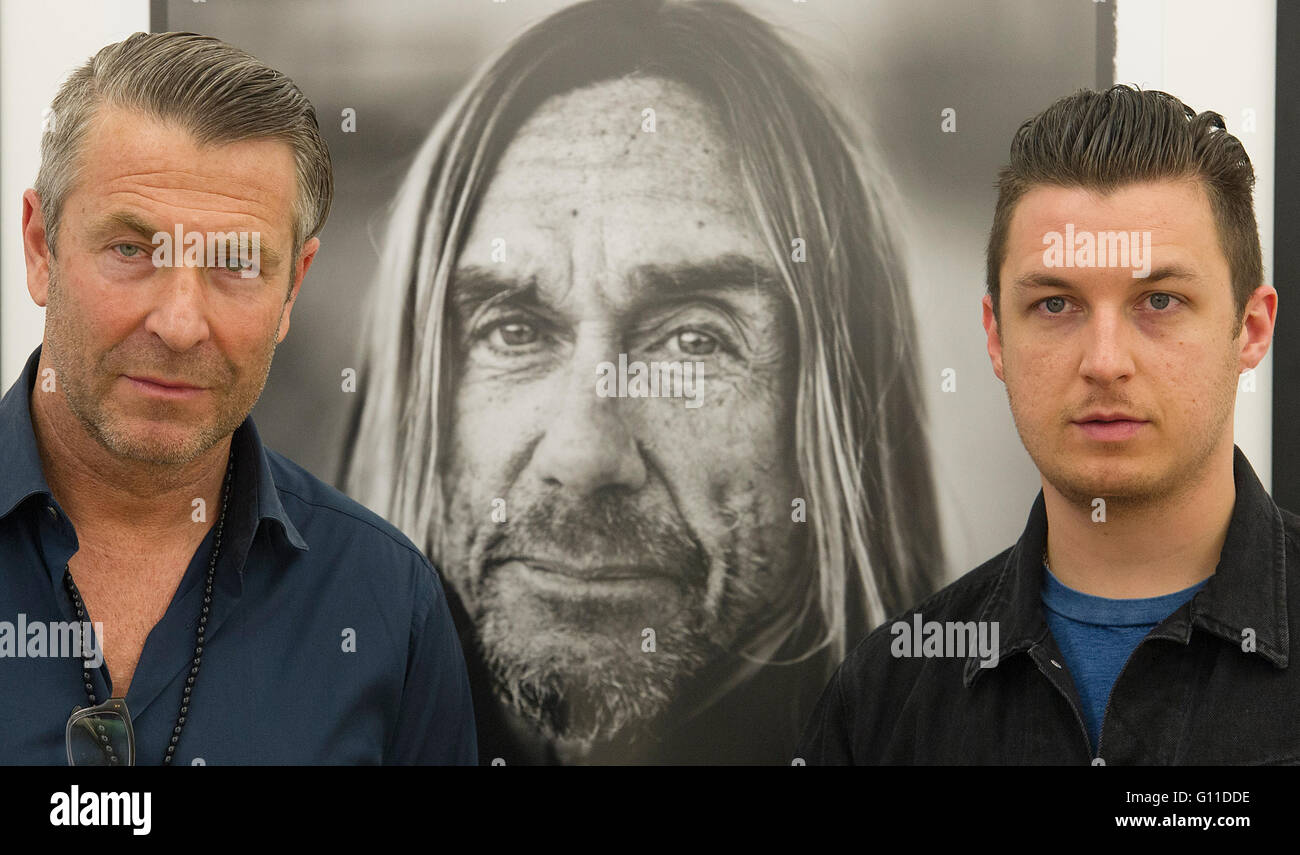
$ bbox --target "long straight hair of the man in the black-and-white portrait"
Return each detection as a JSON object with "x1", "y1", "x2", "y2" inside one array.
[{"x1": 342, "y1": 0, "x2": 944, "y2": 663}]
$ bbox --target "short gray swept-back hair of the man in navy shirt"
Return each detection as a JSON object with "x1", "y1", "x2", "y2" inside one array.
[{"x1": 35, "y1": 32, "x2": 334, "y2": 270}]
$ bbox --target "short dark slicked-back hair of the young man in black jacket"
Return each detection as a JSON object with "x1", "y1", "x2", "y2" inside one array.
[{"x1": 987, "y1": 84, "x2": 1264, "y2": 324}]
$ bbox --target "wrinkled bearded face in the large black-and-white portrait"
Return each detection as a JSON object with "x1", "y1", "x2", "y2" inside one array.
[{"x1": 437, "y1": 78, "x2": 805, "y2": 746}]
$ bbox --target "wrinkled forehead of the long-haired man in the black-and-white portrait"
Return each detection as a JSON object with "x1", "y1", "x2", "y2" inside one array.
[{"x1": 460, "y1": 78, "x2": 767, "y2": 301}]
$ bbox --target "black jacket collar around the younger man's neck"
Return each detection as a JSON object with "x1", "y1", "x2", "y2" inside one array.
[{"x1": 963, "y1": 446, "x2": 1291, "y2": 686}]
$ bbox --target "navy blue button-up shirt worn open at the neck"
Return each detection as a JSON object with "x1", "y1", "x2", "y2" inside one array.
[{"x1": 0, "y1": 347, "x2": 477, "y2": 765}]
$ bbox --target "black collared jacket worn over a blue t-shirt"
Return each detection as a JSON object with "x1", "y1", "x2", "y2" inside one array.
[{"x1": 796, "y1": 448, "x2": 1300, "y2": 765}]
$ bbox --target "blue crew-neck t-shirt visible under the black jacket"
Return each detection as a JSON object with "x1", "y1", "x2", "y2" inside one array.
[{"x1": 1043, "y1": 567, "x2": 1209, "y2": 752}]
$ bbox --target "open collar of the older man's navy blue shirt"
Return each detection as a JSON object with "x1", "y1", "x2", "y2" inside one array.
[{"x1": 0, "y1": 347, "x2": 307, "y2": 550}]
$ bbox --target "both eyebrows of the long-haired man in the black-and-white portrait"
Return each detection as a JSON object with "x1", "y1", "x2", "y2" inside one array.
[{"x1": 451, "y1": 253, "x2": 781, "y2": 313}]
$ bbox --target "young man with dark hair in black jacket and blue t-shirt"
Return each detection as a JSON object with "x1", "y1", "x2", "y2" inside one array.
[{"x1": 798, "y1": 86, "x2": 1300, "y2": 764}]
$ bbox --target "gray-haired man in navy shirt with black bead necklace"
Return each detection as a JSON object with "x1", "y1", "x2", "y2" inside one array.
[{"x1": 0, "y1": 32, "x2": 477, "y2": 765}]
